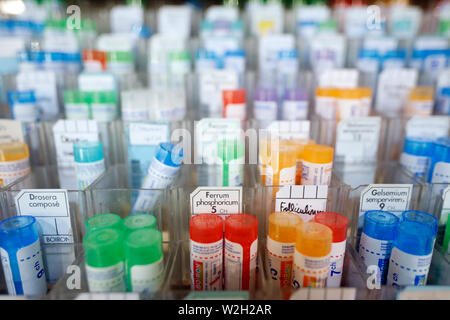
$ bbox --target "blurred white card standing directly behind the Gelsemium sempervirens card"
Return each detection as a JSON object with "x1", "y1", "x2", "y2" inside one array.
[{"x1": 335, "y1": 117, "x2": 381, "y2": 163}]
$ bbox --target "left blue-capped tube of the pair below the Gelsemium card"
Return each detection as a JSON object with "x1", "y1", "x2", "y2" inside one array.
[{"x1": 359, "y1": 210, "x2": 400, "y2": 284}]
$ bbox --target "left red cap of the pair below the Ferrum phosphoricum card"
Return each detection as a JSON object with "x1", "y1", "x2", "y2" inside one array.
[{"x1": 189, "y1": 213, "x2": 223, "y2": 243}]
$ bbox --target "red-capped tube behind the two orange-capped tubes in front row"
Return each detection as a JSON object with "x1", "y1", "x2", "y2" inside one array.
[{"x1": 314, "y1": 212, "x2": 348, "y2": 288}]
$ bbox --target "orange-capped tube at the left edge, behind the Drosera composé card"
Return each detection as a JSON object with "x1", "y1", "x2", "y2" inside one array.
[{"x1": 0, "y1": 142, "x2": 31, "y2": 187}]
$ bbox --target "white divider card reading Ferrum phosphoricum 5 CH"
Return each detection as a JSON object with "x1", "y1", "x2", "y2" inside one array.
[{"x1": 191, "y1": 187, "x2": 242, "y2": 219}]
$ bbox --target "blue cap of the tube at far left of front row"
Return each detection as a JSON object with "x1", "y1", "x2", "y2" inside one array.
[{"x1": 0, "y1": 216, "x2": 39, "y2": 251}]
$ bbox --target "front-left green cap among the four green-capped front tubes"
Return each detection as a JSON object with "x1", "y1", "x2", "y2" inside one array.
[{"x1": 83, "y1": 228, "x2": 124, "y2": 268}]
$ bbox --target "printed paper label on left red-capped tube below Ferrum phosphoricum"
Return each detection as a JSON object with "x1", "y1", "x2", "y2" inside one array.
[{"x1": 190, "y1": 239, "x2": 223, "y2": 291}]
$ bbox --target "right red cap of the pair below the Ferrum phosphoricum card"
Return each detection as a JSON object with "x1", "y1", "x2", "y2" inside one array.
[{"x1": 225, "y1": 213, "x2": 258, "y2": 245}]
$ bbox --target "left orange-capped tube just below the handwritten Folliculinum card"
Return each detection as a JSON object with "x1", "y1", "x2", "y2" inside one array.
[{"x1": 267, "y1": 212, "x2": 303, "y2": 288}]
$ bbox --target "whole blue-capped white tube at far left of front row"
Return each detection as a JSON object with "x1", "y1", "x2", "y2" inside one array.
[{"x1": 0, "y1": 216, "x2": 47, "y2": 296}]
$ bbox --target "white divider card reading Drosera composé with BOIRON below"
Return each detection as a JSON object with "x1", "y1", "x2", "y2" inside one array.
[{"x1": 15, "y1": 189, "x2": 73, "y2": 243}]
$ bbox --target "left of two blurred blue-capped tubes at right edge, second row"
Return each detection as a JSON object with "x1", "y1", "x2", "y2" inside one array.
[{"x1": 400, "y1": 137, "x2": 433, "y2": 177}]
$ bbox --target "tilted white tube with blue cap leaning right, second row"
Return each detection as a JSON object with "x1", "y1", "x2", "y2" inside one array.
[{"x1": 132, "y1": 142, "x2": 183, "y2": 213}]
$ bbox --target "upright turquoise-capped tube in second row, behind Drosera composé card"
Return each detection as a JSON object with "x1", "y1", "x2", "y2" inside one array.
[{"x1": 73, "y1": 141, "x2": 105, "y2": 190}]
